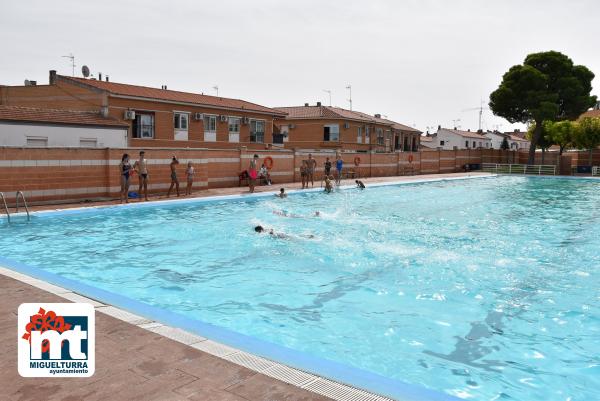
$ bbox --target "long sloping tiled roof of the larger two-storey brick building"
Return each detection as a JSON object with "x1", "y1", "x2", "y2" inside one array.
[{"x1": 59, "y1": 75, "x2": 282, "y2": 115}]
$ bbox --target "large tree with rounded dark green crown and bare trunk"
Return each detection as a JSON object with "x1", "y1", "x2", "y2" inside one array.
[{"x1": 489, "y1": 51, "x2": 596, "y2": 164}]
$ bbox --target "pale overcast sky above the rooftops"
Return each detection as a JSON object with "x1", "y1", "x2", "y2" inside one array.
[{"x1": 0, "y1": 0, "x2": 600, "y2": 131}]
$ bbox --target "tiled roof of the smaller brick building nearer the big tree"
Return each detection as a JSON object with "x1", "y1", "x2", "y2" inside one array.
[{"x1": 276, "y1": 105, "x2": 421, "y2": 133}]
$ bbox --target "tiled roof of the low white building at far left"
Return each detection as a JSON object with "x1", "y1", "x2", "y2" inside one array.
[{"x1": 0, "y1": 105, "x2": 128, "y2": 128}]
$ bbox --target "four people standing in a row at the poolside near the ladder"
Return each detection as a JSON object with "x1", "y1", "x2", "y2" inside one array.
[{"x1": 119, "y1": 151, "x2": 195, "y2": 203}]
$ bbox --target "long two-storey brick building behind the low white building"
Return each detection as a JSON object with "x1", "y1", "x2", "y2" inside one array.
[{"x1": 0, "y1": 71, "x2": 285, "y2": 149}]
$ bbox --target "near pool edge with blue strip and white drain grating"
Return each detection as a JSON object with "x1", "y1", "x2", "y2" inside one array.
[{"x1": 0, "y1": 257, "x2": 458, "y2": 401}]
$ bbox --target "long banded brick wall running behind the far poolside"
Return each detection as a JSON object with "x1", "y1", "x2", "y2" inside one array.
[{"x1": 0, "y1": 147, "x2": 564, "y2": 203}]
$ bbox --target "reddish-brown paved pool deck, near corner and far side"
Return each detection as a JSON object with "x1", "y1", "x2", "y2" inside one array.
[{"x1": 0, "y1": 172, "x2": 490, "y2": 401}]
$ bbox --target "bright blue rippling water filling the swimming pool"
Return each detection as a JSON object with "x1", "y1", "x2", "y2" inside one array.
[{"x1": 0, "y1": 176, "x2": 600, "y2": 401}]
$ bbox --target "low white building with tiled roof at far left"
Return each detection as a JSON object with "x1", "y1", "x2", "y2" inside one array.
[{"x1": 0, "y1": 105, "x2": 128, "y2": 148}]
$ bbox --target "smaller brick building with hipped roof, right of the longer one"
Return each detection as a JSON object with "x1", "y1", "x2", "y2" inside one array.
[{"x1": 275, "y1": 103, "x2": 421, "y2": 152}]
